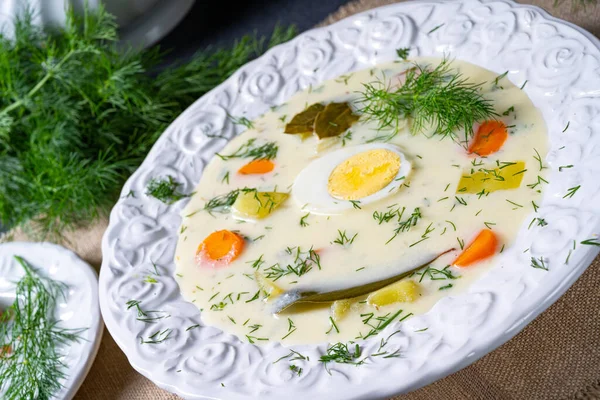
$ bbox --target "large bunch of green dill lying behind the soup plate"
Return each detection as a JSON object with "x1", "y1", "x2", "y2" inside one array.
[{"x1": 0, "y1": 7, "x2": 295, "y2": 237}]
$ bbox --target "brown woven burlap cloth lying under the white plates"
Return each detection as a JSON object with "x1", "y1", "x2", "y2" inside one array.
[{"x1": 8, "y1": 0, "x2": 600, "y2": 400}]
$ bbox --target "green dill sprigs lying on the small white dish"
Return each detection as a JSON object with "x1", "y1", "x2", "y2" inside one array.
[{"x1": 0, "y1": 256, "x2": 83, "y2": 400}]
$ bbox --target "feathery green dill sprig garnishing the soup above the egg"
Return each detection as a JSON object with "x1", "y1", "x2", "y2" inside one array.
[{"x1": 358, "y1": 59, "x2": 497, "y2": 141}]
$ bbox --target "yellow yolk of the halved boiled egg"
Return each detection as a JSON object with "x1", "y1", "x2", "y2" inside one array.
[{"x1": 327, "y1": 149, "x2": 400, "y2": 200}]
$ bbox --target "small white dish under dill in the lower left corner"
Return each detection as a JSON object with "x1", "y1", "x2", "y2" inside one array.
[{"x1": 0, "y1": 242, "x2": 104, "y2": 400}]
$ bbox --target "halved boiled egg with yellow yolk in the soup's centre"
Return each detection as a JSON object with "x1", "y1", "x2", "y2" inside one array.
[{"x1": 292, "y1": 143, "x2": 411, "y2": 215}]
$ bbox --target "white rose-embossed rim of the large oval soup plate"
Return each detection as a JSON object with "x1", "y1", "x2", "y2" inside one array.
[{"x1": 100, "y1": 0, "x2": 600, "y2": 400}]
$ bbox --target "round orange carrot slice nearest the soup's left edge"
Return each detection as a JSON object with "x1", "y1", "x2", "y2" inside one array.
[{"x1": 196, "y1": 230, "x2": 245, "y2": 267}]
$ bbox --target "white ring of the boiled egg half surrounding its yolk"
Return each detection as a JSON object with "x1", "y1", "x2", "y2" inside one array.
[{"x1": 292, "y1": 143, "x2": 411, "y2": 215}]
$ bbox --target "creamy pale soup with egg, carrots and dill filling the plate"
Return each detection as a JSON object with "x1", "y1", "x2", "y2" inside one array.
[{"x1": 176, "y1": 58, "x2": 547, "y2": 344}]
